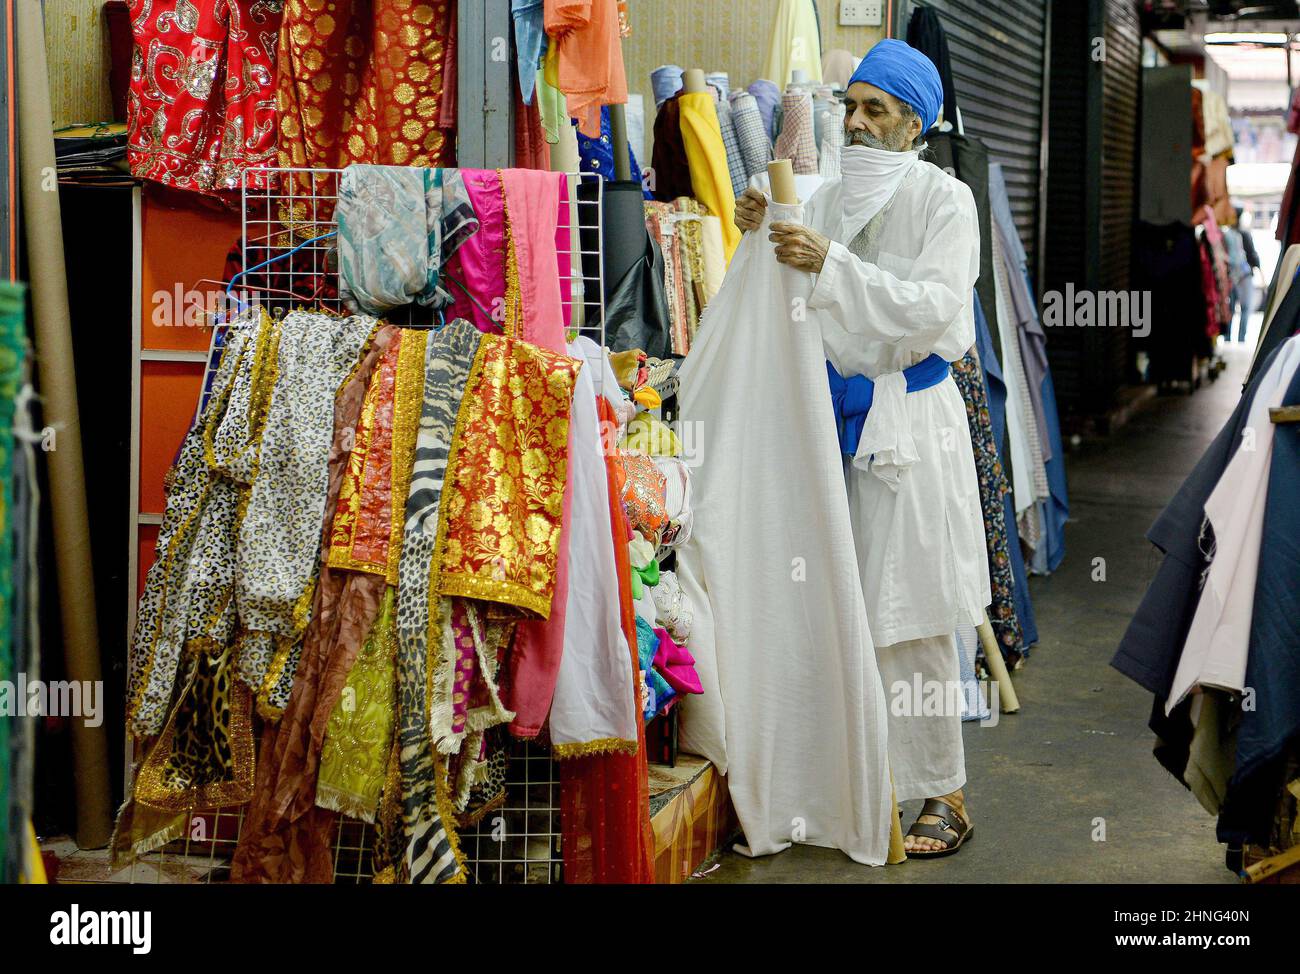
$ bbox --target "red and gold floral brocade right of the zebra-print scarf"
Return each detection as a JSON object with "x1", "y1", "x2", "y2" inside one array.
[{"x1": 432, "y1": 334, "x2": 580, "y2": 619}]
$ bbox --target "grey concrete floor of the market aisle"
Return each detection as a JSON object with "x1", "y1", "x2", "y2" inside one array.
[{"x1": 697, "y1": 346, "x2": 1249, "y2": 883}]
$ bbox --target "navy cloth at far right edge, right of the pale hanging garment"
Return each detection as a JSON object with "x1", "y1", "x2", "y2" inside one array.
[{"x1": 1218, "y1": 353, "x2": 1300, "y2": 843}]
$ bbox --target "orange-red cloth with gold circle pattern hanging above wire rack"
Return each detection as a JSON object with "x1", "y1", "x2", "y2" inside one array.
[{"x1": 277, "y1": 0, "x2": 455, "y2": 235}]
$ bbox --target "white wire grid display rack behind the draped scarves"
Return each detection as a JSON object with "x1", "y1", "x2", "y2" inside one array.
[{"x1": 129, "y1": 169, "x2": 605, "y2": 884}]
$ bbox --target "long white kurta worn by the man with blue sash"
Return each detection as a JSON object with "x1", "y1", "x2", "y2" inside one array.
[{"x1": 805, "y1": 161, "x2": 991, "y2": 646}]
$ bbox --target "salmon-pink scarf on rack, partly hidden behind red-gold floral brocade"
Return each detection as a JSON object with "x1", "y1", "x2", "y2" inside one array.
[{"x1": 502, "y1": 169, "x2": 573, "y2": 737}]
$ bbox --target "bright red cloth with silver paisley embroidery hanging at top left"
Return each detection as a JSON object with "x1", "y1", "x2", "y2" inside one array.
[{"x1": 126, "y1": 0, "x2": 281, "y2": 194}]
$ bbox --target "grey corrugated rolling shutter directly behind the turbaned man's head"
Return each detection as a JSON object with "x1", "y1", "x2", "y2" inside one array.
[{"x1": 896, "y1": 0, "x2": 1048, "y2": 268}]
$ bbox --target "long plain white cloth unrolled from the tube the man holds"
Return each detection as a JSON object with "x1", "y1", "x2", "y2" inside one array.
[{"x1": 676, "y1": 193, "x2": 892, "y2": 865}]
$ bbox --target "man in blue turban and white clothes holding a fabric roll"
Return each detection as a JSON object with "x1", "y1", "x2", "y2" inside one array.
[{"x1": 736, "y1": 39, "x2": 991, "y2": 857}]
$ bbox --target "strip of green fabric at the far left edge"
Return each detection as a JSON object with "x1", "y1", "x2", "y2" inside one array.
[{"x1": 0, "y1": 282, "x2": 26, "y2": 883}]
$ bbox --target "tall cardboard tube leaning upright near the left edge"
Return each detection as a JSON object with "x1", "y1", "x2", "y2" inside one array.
[{"x1": 16, "y1": 3, "x2": 112, "y2": 849}]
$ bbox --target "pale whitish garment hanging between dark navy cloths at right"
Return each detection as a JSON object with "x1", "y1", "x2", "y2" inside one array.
[{"x1": 1165, "y1": 338, "x2": 1300, "y2": 714}]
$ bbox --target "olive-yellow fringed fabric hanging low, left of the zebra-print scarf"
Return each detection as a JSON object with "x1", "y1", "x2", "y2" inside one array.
[{"x1": 316, "y1": 586, "x2": 397, "y2": 822}]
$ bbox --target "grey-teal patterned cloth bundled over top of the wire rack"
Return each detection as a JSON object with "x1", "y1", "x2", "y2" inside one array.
[{"x1": 335, "y1": 165, "x2": 478, "y2": 315}]
